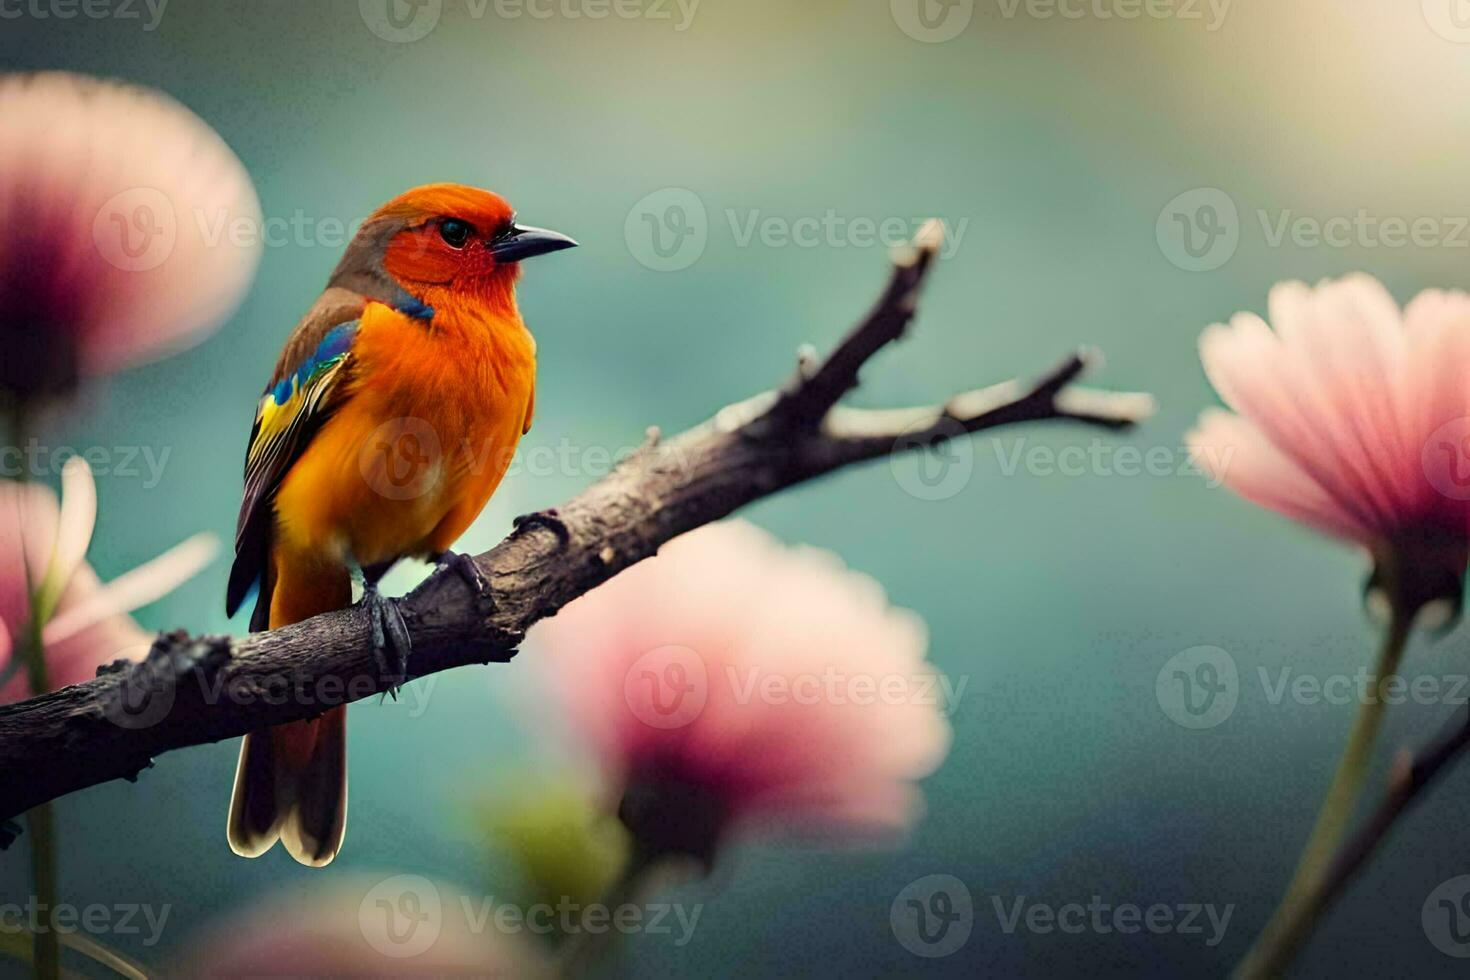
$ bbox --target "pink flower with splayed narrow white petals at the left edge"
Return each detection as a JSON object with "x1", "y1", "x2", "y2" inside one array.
[{"x1": 0, "y1": 457, "x2": 216, "y2": 704}]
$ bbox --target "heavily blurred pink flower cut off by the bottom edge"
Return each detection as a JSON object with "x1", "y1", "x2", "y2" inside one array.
[{"x1": 169, "y1": 874, "x2": 551, "y2": 980}]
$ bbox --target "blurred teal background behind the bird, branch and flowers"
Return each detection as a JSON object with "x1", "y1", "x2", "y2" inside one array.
[{"x1": 0, "y1": 0, "x2": 1470, "y2": 977}]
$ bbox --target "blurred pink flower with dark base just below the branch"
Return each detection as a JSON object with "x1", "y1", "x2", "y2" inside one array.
[{"x1": 535, "y1": 522, "x2": 950, "y2": 862}]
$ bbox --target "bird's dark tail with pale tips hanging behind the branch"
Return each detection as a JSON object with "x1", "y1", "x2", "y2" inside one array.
[{"x1": 228, "y1": 554, "x2": 351, "y2": 867}]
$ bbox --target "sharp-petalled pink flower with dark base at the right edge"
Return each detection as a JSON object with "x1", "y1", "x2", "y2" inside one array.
[{"x1": 1188, "y1": 275, "x2": 1470, "y2": 614}]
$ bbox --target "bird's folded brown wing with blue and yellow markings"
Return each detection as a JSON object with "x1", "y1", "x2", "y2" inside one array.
[{"x1": 225, "y1": 288, "x2": 368, "y2": 629}]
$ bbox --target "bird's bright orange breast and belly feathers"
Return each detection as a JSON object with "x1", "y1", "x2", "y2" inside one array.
[{"x1": 276, "y1": 304, "x2": 535, "y2": 566}]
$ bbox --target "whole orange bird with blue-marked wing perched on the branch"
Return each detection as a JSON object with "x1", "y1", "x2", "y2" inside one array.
[{"x1": 226, "y1": 184, "x2": 576, "y2": 867}]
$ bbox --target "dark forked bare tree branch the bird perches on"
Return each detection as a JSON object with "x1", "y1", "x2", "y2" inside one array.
[{"x1": 0, "y1": 222, "x2": 1152, "y2": 836}]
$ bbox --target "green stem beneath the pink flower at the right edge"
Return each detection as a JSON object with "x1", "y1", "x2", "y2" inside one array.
[{"x1": 1235, "y1": 604, "x2": 1414, "y2": 980}]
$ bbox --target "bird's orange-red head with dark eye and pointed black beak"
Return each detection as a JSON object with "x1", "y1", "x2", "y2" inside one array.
[{"x1": 331, "y1": 184, "x2": 576, "y2": 318}]
